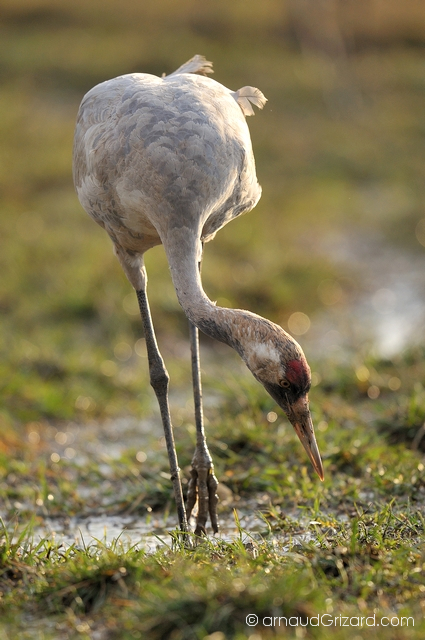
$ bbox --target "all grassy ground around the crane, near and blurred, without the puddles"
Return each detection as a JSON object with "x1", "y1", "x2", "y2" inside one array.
[{"x1": 0, "y1": 0, "x2": 425, "y2": 640}]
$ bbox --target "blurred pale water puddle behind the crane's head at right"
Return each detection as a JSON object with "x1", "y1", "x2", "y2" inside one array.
[{"x1": 302, "y1": 232, "x2": 425, "y2": 359}]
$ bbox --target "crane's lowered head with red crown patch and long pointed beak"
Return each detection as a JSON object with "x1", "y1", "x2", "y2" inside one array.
[{"x1": 241, "y1": 319, "x2": 324, "y2": 480}]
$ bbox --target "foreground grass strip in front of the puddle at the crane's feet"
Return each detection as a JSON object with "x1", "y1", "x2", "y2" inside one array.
[{"x1": 0, "y1": 504, "x2": 425, "y2": 638}]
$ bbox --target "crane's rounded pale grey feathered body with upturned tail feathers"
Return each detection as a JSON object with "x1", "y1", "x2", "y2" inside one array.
[{"x1": 74, "y1": 56, "x2": 265, "y2": 268}]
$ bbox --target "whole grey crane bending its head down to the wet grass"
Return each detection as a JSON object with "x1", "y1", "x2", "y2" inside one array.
[{"x1": 73, "y1": 55, "x2": 323, "y2": 535}]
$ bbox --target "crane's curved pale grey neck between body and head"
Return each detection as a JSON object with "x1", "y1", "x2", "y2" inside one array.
[{"x1": 164, "y1": 227, "x2": 248, "y2": 355}]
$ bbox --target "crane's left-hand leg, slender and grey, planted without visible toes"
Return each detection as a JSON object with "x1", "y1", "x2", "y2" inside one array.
[{"x1": 136, "y1": 285, "x2": 189, "y2": 533}]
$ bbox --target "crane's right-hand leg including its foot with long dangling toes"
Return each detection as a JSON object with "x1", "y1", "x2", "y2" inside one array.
[{"x1": 186, "y1": 322, "x2": 218, "y2": 536}]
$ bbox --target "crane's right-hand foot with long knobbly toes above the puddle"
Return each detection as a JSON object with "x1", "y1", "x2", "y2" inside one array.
[{"x1": 186, "y1": 450, "x2": 218, "y2": 536}]
